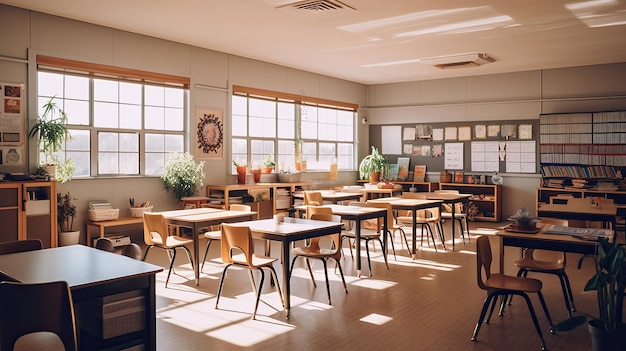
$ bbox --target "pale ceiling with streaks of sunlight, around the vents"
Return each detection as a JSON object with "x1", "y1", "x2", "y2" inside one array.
[{"x1": 0, "y1": 0, "x2": 626, "y2": 84}]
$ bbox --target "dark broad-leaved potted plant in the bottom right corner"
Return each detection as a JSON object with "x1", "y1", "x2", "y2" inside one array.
[{"x1": 555, "y1": 238, "x2": 626, "y2": 351}]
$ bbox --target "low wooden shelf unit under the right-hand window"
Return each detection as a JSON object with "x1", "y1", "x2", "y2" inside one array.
[{"x1": 206, "y1": 182, "x2": 315, "y2": 219}]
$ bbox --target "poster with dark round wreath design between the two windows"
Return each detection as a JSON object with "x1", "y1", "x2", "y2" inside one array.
[{"x1": 196, "y1": 107, "x2": 224, "y2": 159}]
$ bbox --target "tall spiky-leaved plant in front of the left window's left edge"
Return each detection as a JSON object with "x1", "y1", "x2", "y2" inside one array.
[{"x1": 28, "y1": 97, "x2": 74, "y2": 179}]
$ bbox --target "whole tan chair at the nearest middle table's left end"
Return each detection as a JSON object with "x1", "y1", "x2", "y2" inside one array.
[{"x1": 215, "y1": 223, "x2": 285, "y2": 319}]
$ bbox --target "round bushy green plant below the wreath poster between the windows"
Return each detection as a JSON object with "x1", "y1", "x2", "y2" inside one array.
[{"x1": 161, "y1": 153, "x2": 204, "y2": 202}]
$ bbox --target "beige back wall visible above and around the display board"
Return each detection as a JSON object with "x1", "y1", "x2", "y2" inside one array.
[{"x1": 362, "y1": 63, "x2": 626, "y2": 218}]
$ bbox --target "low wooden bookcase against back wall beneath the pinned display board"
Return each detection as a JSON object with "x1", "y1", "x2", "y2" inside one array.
[{"x1": 439, "y1": 183, "x2": 502, "y2": 222}]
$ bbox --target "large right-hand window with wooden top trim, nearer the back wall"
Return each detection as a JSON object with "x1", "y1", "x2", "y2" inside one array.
[{"x1": 232, "y1": 86, "x2": 358, "y2": 173}]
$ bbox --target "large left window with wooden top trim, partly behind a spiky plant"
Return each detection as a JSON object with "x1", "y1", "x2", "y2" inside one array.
[{"x1": 37, "y1": 56, "x2": 189, "y2": 177}]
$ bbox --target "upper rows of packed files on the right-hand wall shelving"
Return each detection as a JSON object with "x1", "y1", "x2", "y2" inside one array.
[{"x1": 539, "y1": 111, "x2": 626, "y2": 166}]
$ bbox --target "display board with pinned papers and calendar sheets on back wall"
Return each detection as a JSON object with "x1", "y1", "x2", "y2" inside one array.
[{"x1": 369, "y1": 119, "x2": 539, "y2": 177}]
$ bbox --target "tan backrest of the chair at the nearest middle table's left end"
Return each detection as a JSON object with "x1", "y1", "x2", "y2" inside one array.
[{"x1": 221, "y1": 223, "x2": 256, "y2": 268}]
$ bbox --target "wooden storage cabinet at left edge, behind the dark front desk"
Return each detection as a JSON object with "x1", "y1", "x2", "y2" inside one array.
[{"x1": 0, "y1": 181, "x2": 58, "y2": 247}]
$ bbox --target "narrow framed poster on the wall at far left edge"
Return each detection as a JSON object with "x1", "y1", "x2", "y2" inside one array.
[{"x1": 0, "y1": 82, "x2": 25, "y2": 150}]
